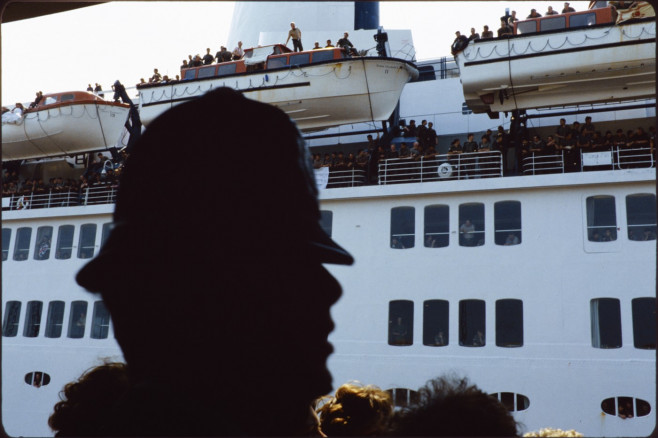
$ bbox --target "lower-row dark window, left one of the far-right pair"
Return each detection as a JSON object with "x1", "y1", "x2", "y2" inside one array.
[{"x1": 590, "y1": 298, "x2": 621, "y2": 348}]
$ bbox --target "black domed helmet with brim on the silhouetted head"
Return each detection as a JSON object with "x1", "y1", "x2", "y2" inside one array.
[{"x1": 76, "y1": 88, "x2": 354, "y2": 292}]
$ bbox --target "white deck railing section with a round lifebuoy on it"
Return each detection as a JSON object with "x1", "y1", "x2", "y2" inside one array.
[{"x1": 379, "y1": 151, "x2": 503, "y2": 185}]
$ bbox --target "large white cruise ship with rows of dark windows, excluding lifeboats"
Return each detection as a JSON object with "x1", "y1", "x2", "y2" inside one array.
[{"x1": 2, "y1": 2, "x2": 656, "y2": 436}]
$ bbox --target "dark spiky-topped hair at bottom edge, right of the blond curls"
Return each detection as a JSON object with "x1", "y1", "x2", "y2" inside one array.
[{"x1": 391, "y1": 376, "x2": 517, "y2": 436}]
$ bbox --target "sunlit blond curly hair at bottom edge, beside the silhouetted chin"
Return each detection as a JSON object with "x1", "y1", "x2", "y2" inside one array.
[{"x1": 316, "y1": 382, "x2": 393, "y2": 436}]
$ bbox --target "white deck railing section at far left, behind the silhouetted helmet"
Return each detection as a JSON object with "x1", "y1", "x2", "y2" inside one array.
[{"x1": 2, "y1": 185, "x2": 118, "y2": 211}]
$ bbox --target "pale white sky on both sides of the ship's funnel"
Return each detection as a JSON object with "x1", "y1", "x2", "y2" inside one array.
[{"x1": 0, "y1": 1, "x2": 589, "y2": 105}]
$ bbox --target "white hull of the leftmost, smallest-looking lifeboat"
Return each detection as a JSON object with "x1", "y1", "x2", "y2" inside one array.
[{"x1": 2, "y1": 103, "x2": 129, "y2": 161}]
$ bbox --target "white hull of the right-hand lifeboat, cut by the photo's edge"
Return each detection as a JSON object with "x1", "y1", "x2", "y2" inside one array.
[{"x1": 455, "y1": 22, "x2": 656, "y2": 112}]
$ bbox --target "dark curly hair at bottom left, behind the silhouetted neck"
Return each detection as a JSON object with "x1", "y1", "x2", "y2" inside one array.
[{"x1": 48, "y1": 362, "x2": 130, "y2": 436}]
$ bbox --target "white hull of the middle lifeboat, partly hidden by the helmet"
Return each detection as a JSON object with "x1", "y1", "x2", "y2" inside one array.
[{"x1": 140, "y1": 58, "x2": 418, "y2": 131}]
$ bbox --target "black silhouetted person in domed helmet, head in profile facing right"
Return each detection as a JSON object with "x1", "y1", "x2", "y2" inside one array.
[{"x1": 77, "y1": 88, "x2": 353, "y2": 436}]
